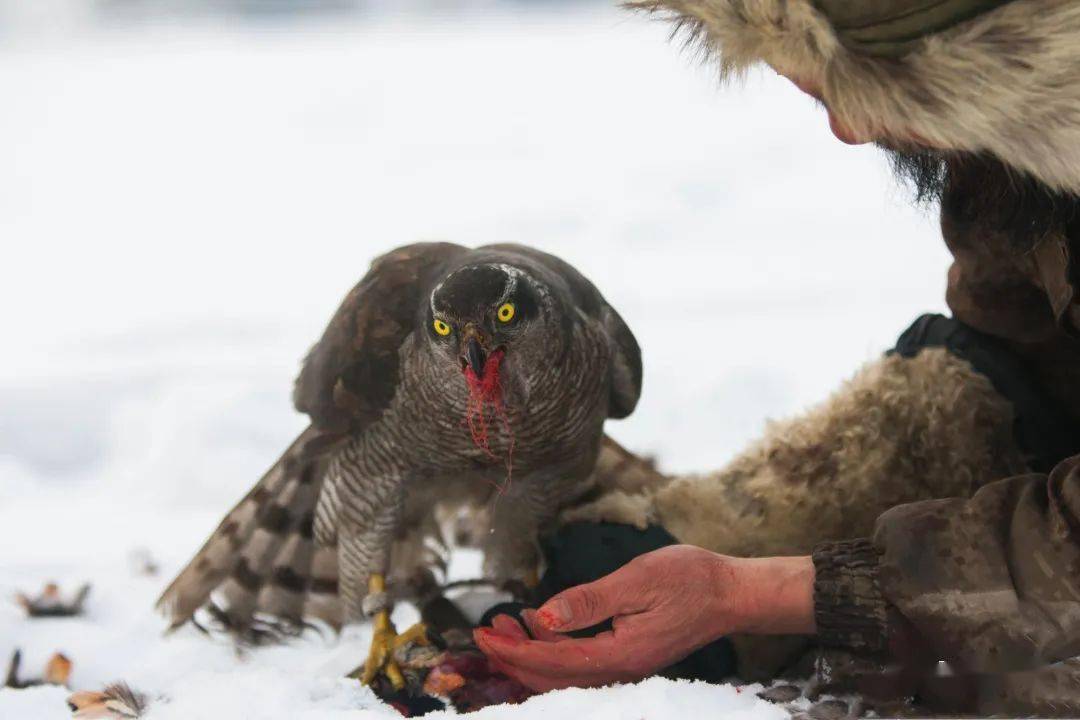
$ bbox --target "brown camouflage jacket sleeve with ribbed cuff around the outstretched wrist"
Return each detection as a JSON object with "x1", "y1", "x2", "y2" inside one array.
[{"x1": 813, "y1": 456, "x2": 1080, "y2": 673}]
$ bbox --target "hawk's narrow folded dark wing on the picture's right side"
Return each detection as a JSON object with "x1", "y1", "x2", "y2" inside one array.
[{"x1": 476, "y1": 244, "x2": 642, "y2": 419}]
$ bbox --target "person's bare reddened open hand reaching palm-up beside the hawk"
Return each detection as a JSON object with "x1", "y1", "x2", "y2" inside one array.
[{"x1": 473, "y1": 545, "x2": 814, "y2": 692}]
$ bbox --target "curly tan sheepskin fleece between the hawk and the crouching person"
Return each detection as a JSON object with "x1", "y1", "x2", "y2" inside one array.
[{"x1": 563, "y1": 349, "x2": 1028, "y2": 681}]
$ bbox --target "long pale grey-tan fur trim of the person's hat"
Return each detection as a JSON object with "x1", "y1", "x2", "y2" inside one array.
[{"x1": 627, "y1": 0, "x2": 1080, "y2": 193}]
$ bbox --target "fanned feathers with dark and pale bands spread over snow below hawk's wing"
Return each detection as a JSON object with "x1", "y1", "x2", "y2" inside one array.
[{"x1": 157, "y1": 427, "x2": 341, "y2": 642}]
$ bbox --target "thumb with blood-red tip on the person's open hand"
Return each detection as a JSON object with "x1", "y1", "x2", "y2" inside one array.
[{"x1": 537, "y1": 567, "x2": 644, "y2": 631}]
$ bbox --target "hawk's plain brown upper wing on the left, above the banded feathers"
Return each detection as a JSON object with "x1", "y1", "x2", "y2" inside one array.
[{"x1": 293, "y1": 243, "x2": 469, "y2": 433}]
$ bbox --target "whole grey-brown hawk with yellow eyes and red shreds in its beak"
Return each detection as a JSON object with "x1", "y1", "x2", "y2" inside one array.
[{"x1": 158, "y1": 243, "x2": 642, "y2": 687}]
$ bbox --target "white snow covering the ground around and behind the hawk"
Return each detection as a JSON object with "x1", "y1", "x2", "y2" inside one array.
[{"x1": 0, "y1": 5, "x2": 947, "y2": 720}]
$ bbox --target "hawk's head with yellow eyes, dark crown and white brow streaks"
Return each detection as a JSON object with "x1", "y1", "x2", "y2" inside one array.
[{"x1": 426, "y1": 262, "x2": 562, "y2": 379}]
